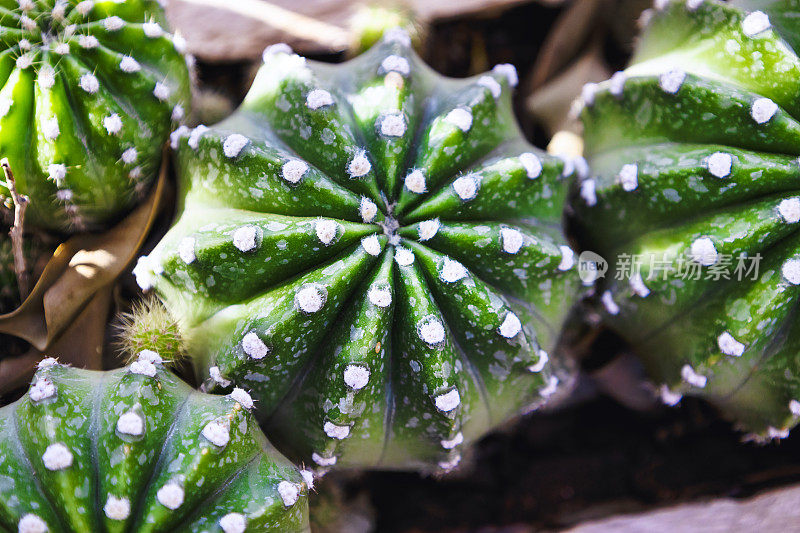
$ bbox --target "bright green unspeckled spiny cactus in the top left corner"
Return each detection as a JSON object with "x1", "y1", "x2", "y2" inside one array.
[{"x1": 0, "y1": 0, "x2": 189, "y2": 231}]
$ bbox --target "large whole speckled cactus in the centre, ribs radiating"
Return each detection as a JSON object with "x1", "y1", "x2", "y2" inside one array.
[{"x1": 136, "y1": 32, "x2": 580, "y2": 468}]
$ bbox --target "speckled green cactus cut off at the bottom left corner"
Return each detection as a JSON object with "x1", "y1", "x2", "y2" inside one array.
[{"x1": 0, "y1": 351, "x2": 313, "y2": 533}]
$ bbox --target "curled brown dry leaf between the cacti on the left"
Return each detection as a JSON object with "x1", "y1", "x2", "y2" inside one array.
[{"x1": 0, "y1": 157, "x2": 167, "y2": 351}]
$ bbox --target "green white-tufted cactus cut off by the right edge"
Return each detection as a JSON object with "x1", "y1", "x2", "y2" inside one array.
[{"x1": 577, "y1": 0, "x2": 800, "y2": 437}]
